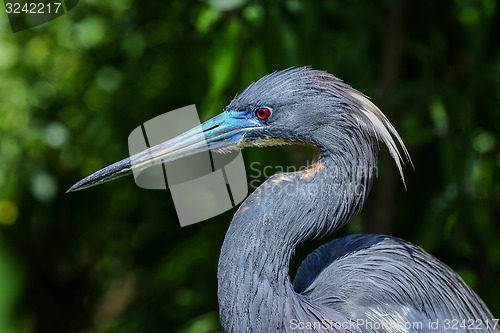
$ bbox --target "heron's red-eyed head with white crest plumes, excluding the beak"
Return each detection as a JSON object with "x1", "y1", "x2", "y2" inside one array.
[{"x1": 222, "y1": 67, "x2": 411, "y2": 177}]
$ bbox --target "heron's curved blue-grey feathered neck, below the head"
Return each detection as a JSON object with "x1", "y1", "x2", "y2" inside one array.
[{"x1": 218, "y1": 128, "x2": 377, "y2": 332}]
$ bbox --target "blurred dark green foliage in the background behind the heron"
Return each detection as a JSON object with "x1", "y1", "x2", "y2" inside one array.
[{"x1": 0, "y1": 0, "x2": 500, "y2": 333}]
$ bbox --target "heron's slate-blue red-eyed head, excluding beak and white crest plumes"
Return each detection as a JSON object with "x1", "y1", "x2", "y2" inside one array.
[{"x1": 219, "y1": 67, "x2": 362, "y2": 148}]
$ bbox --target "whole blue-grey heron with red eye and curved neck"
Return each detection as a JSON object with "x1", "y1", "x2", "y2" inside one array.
[{"x1": 69, "y1": 67, "x2": 500, "y2": 333}]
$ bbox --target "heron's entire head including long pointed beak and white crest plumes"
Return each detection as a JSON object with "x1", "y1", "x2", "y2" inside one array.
[{"x1": 68, "y1": 67, "x2": 407, "y2": 191}]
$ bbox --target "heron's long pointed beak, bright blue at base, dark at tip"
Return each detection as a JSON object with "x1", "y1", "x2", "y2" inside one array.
[{"x1": 66, "y1": 111, "x2": 261, "y2": 193}]
